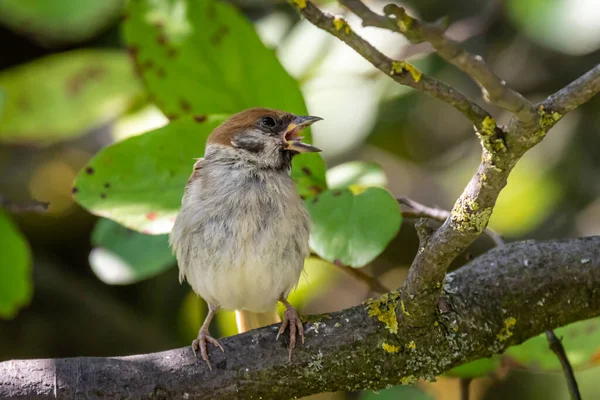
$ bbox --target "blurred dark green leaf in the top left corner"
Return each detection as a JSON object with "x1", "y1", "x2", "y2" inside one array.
[{"x1": 0, "y1": 0, "x2": 123, "y2": 46}]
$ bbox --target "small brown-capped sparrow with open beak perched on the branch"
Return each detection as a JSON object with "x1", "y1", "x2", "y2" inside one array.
[{"x1": 169, "y1": 108, "x2": 322, "y2": 368}]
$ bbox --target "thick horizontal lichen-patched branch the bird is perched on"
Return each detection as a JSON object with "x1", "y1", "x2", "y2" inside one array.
[{"x1": 0, "y1": 237, "x2": 600, "y2": 400}]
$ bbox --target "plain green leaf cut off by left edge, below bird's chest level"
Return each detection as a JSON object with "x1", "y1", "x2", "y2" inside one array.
[{"x1": 0, "y1": 209, "x2": 33, "y2": 318}]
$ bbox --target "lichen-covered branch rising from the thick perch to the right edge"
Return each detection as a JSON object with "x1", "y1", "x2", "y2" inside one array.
[{"x1": 402, "y1": 62, "x2": 600, "y2": 325}]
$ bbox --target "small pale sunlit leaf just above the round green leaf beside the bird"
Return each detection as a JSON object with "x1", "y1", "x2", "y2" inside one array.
[{"x1": 327, "y1": 161, "x2": 387, "y2": 189}]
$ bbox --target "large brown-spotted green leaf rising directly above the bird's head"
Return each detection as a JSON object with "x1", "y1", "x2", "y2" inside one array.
[{"x1": 123, "y1": 0, "x2": 306, "y2": 122}]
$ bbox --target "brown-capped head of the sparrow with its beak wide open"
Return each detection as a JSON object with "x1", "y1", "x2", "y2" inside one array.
[{"x1": 206, "y1": 108, "x2": 322, "y2": 168}]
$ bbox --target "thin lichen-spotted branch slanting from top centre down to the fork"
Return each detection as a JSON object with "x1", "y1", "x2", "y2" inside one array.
[{"x1": 290, "y1": 0, "x2": 489, "y2": 128}]
